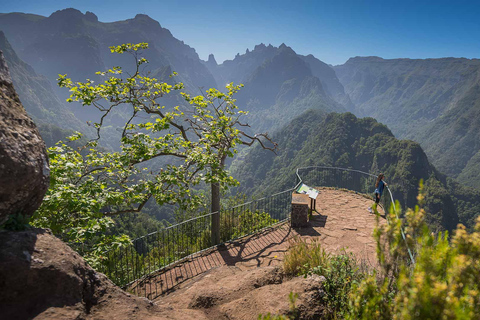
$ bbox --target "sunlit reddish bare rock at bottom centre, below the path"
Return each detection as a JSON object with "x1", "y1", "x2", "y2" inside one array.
[{"x1": 156, "y1": 266, "x2": 325, "y2": 320}]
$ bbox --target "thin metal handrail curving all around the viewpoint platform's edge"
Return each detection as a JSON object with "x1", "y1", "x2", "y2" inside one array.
[{"x1": 105, "y1": 166, "x2": 415, "y2": 296}]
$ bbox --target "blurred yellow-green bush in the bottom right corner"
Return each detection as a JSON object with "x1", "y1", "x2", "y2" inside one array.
[{"x1": 348, "y1": 181, "x2": 480, "y2": 319}]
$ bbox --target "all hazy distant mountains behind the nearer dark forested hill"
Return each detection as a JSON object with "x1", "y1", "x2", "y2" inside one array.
[{"x1": 0, "y1": 8, "x2": 480, "y2": 192}]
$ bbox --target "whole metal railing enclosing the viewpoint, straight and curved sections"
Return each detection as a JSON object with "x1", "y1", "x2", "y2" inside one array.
[{"x1": 100, "y1": 166, "x2": 414, "y2": 296}]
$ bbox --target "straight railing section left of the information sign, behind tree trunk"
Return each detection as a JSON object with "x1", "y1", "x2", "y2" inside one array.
[{"x1": 100, "y1": 188, "x2": 294, "y2": 288}]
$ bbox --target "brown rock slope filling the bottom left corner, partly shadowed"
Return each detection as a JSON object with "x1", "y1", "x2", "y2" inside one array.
[{"x1": 0, "y1": 229, "x2": 205, "y2": 320}]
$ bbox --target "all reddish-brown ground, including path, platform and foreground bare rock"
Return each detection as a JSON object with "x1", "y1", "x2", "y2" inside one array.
[{"x1": 0, "y1": 190, "x2": 385, "y2": 320}]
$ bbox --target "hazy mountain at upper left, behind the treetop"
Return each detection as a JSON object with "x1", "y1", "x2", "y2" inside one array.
[{"x1": 0, "y1": 8, "x2": 216, "y2": 125}]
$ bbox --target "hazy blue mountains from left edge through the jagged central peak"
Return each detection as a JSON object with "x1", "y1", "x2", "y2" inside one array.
[{"x1": 0, "y1": 8, "x2": 353, "y2": 136}]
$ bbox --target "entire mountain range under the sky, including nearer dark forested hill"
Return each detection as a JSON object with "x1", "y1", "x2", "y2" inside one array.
[{"x1": 0, "y1": 9, "x2": 480, "y2": 228}]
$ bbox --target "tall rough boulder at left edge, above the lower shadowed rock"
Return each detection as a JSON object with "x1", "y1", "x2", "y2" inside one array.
[{"x1": 0, "y1": 51, "x2": 49, "y2": 225}]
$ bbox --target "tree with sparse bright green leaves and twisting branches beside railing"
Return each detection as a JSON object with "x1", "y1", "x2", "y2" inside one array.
[{"x1": 33, "y1": 43, "x2": 276, "y2": 262}]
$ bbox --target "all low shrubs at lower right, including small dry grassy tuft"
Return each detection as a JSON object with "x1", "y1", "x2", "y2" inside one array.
[{"x1": 268, "y1": 184, "x2": 480, "y2": 320}]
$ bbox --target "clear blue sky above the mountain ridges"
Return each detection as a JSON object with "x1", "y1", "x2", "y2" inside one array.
[{"x1": 0, "y1": 0, "x2": 480, "y2": 65}]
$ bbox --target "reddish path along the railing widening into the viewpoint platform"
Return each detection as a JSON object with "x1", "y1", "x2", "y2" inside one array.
[{"x1": 132, "y1": 189, "x2": 386, "y2": 299}]
